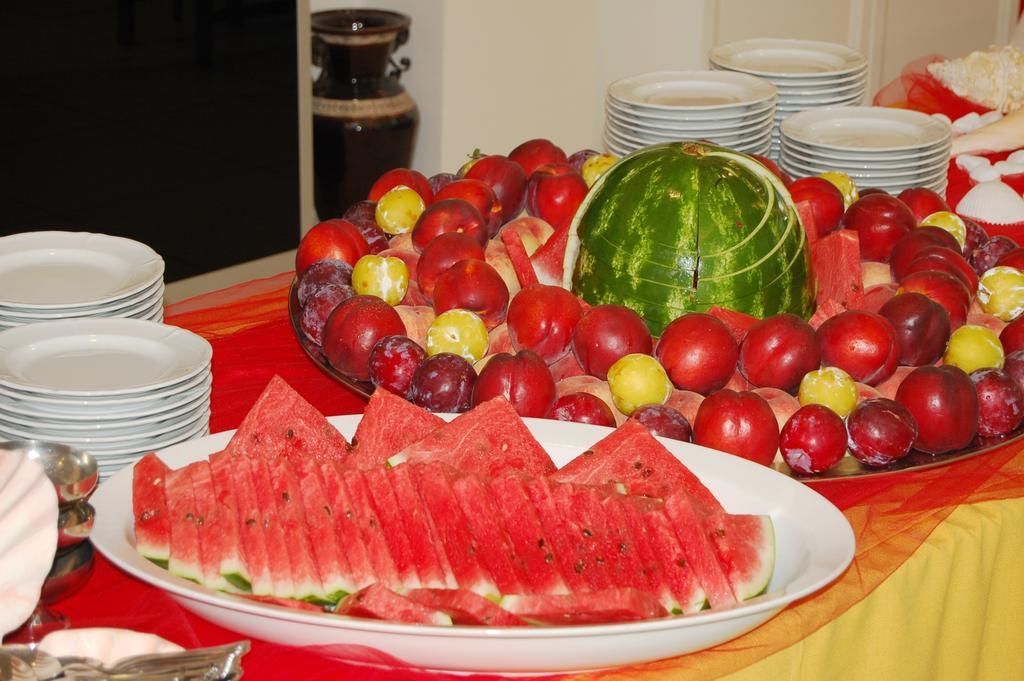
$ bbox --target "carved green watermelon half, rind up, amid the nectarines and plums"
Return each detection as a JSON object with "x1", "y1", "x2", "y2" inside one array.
[{"x1": 563, "y1": 141, "x2": 815, "y2": 336}]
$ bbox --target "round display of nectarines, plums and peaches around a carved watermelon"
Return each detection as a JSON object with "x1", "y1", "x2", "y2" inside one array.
[{"x1": 289, "y1": 139, "x2": 1024, "y2": 477}]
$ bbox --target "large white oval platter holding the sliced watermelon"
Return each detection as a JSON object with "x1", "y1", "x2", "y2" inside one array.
[{"x1": 90, "y1": 416, "x2": 854, "y2": 673}]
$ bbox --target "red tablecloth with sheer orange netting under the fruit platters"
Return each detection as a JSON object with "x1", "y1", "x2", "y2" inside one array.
[{"x1": 51, "y1": 273, "x2": 1024, "y2": 679}]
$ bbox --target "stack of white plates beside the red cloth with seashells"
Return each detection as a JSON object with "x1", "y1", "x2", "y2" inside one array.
[{"x1": 779, "y1": 107, "x2": 952, "y2": 194}]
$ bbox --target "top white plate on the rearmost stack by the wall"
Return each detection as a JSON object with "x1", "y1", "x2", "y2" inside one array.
[{"x1": 708, "y1": 38, "x2": 867, "y2": 79}]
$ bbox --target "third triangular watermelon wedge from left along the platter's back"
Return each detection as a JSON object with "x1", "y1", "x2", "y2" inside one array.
[{"x1": 388, "y1": 397, "x2": 555, "y2": 477}]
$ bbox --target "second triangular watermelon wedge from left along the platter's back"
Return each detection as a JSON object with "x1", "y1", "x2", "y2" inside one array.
[{"x1": 345, "y1": 388, "x2": 444, "y2": 468}]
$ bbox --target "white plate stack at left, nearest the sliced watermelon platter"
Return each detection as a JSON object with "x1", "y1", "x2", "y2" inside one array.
[{"x1": 0, "y1": 317, "x2": 213, "y2": 477}]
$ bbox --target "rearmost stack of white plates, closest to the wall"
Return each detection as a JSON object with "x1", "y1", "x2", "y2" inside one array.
[{"x1": 708, "y1": 38, "x2": 867, "y2": 159}]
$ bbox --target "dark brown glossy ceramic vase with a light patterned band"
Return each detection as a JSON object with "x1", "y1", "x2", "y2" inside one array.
[{"x1": 311, "y1": 9, "x2": 420, "y2": 220}]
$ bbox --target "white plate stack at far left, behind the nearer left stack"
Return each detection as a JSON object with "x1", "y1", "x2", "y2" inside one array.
[{"x1": 0, "y1": 231, "x2": 164, "y2": 329}]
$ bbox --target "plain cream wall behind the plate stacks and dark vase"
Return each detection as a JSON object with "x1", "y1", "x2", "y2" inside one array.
[{"x1": 300, "y1": 0, "x2": 1017, "y2": 208}]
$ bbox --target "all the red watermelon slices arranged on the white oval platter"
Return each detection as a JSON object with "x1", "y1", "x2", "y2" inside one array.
[{"x1": 132, "y1": 374, "x2": 775, "y2": 627}]
